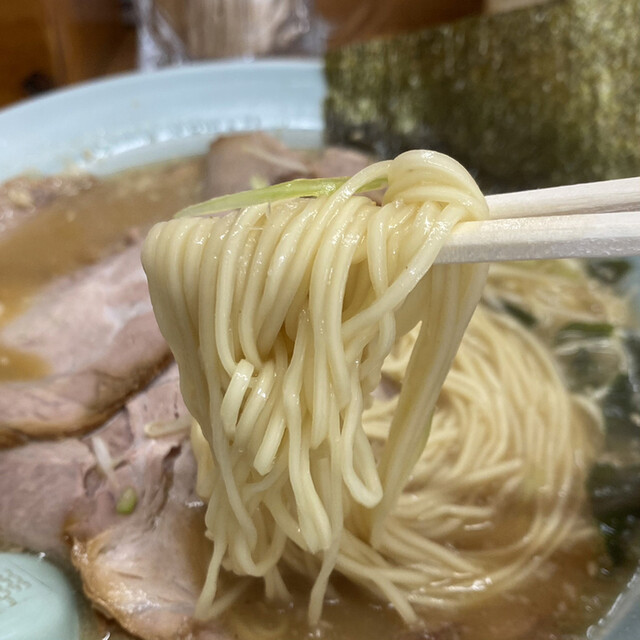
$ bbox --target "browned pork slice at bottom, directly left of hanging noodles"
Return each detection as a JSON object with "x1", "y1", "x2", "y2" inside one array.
[{"x1": 67, "y1": 367, "x2": 228, "y2": 640}]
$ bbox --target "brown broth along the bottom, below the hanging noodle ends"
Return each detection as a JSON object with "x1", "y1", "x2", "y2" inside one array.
[{"x1": 51, "y1": 532, "x2": 632, "y2": 640}]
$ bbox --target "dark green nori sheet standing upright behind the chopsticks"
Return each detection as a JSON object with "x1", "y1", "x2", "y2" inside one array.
[{"x1": 325, "y1": 0, "x2": 640, "y2": 190}]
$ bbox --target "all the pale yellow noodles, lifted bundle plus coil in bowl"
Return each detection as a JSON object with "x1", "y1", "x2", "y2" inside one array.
[{"x1": 143, "y1": 151, "x2": 600, "y2": 623}]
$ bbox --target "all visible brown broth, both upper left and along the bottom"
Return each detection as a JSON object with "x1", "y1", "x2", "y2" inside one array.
[{"x1": 0, "y1": 158, "x2": 634, "y2": 640}]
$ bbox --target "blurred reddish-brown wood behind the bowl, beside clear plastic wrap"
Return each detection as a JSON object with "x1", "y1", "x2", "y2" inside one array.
[{"x1": 0, "y1": 0, "x2": 544, "y2": 107}]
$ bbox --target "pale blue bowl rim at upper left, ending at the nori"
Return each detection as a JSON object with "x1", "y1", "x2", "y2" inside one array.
[{"x1": 0, "y1": 59, "x2": 325, "y2": 180}]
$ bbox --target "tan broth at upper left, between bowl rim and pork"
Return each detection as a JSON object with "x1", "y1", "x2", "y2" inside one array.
[{"x1": 0, "y1": 158, "x2": 204, "y2": 381}]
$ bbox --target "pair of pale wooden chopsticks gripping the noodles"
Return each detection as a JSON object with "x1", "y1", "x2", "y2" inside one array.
[{"x1": 436, "y1": 177, "x2": 640, "y2": 264}]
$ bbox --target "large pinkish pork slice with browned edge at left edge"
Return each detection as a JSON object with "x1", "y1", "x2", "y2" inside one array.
[{"x1": 0, "y1": 243, "x2": 171, "y2": 446}]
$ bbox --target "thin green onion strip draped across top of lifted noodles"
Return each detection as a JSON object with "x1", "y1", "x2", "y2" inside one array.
[{"x1": 174, "y1": 178, "x2": 386, "y2": 218}]
